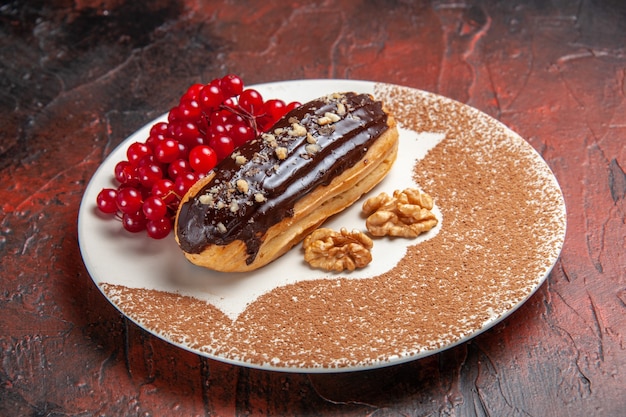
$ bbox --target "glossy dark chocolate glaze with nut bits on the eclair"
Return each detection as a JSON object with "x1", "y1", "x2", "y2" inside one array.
[{"x1": 176, "y1": 93, "x2": 388, "y2": 264}]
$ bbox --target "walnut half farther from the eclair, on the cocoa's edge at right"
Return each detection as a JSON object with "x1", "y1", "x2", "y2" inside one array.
[{"x1": 363, "y1": 188, "x2": 437, "y2": 238}]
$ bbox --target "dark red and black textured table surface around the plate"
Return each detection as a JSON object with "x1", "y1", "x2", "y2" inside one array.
[{"x1": 0, "y1": 0, "x2": 626, "y2": 417}]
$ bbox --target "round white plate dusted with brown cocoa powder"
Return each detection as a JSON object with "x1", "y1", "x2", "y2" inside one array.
[{"x1": 78, "y1": 80, "x2": 565, "y2": 372}]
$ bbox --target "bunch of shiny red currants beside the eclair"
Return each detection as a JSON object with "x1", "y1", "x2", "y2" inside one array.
[{"x1": 96, "y1": 74, "x2": 300, "y2": 239}]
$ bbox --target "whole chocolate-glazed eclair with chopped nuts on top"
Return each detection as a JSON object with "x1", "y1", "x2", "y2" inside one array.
[{"x1": 174, "y1": 92, "x2": 398, "y2": 272}]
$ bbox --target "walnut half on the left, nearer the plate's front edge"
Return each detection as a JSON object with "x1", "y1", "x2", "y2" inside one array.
[{"x1": 302, "y1": 227, "x2": 374, "y2": 272}]
